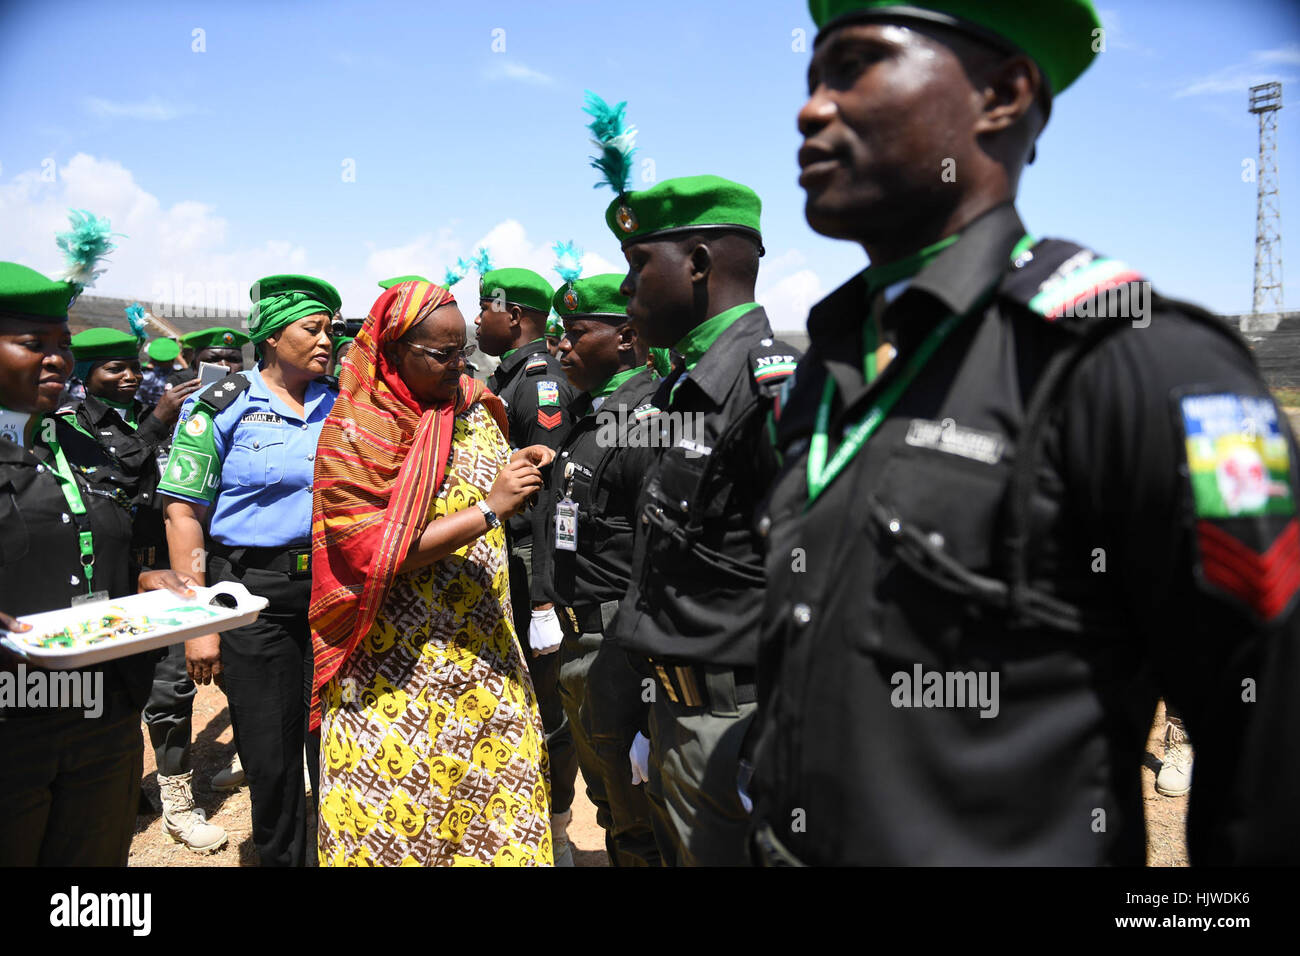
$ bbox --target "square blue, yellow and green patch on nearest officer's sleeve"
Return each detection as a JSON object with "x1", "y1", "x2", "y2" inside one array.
[{"x1": 1179, "y1": 393, "x2": 1295, "y2": 518}]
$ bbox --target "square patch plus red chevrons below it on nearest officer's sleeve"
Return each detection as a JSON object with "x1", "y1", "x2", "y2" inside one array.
[{"x1": 1179, "y1": 393, "x2": 1300, "y2": 620}]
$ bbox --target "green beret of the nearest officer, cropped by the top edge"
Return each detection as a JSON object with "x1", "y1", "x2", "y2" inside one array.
[{"x1": 809, "y1": 0, "x2": 1101, "y2": 96}]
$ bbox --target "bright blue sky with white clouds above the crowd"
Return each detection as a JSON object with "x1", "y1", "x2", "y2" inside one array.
[{"x1": 0, "y1": 0, "x2": 1300, "y2": 328}]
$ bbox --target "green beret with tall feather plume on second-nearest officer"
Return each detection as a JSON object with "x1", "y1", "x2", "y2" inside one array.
[{"x1": 605, "y1": 176, "x2": 763, "y2": 246}]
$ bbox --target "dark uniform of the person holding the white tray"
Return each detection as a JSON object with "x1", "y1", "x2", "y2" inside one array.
[{"x1": 0, "y1": 419, "x2": 159, "y2": 866}]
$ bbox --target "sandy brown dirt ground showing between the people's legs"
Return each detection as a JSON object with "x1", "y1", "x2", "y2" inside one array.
[{"x1": 130, "y1": 684, "x2": 1187, "y2": 866}]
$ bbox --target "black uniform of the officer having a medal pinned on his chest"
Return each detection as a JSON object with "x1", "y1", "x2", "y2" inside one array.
[{"x1": 533, "y1": 369, "x2": 660, "y2": 866}]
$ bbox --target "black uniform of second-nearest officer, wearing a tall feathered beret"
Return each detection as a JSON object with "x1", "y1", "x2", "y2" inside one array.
[{"x1": 612, "y1": 307, "x2": 798, "y2": 866}]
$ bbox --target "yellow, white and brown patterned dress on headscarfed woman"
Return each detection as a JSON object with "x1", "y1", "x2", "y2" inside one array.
[{"x1": 319, "y1": 403, "x2": 551, "y2": 866}]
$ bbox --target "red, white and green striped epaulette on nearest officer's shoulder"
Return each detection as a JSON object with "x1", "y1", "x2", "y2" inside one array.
[{"x1": 998, "y1": 239, "x2": 1149, "y2": 329}]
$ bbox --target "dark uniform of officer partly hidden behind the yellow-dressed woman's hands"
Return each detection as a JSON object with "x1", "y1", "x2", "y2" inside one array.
[{"x1": 488, "y1": 339, "x2": 581, "y2": 813}]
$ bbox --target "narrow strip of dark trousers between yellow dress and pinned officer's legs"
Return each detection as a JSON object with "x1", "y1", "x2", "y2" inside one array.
[{"x1": 510, "y1": 540, "x2": 577, "y2": 813}]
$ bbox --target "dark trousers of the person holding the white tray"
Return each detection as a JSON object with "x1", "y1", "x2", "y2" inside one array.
[{"x1": 0, "y1": 698, "x2": 144, "y2": 866}]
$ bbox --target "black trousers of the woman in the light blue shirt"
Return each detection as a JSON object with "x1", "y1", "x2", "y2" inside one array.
[{"x1": 208, "y1": 555, "x2": 320, "y2": 866}]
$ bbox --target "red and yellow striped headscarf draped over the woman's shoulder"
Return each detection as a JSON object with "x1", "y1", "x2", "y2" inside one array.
[{"x1": 308, "y1": 281, "x2": 507, "y2": 728}]
